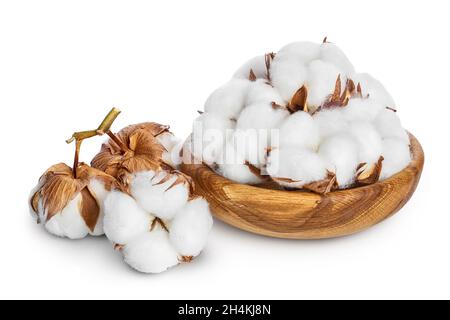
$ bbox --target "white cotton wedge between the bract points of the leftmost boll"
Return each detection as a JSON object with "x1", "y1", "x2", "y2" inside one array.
[{"x1": 43, "y1": 194, "x2": 89, "y2": 239}]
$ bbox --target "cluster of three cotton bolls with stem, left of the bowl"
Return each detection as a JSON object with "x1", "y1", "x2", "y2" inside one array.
[{"x1": 30, "y1": 109, "x2": 212, "y2": 273}]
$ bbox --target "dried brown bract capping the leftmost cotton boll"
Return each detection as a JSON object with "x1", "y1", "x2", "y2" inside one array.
[{"x1": 30, "y1": 163, "x2": 116, "y2": 231}]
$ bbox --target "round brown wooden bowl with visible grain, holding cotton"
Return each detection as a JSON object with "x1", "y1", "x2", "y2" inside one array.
[{"x1": 182, "y1": 134, "x2": 424, "y2": 239}]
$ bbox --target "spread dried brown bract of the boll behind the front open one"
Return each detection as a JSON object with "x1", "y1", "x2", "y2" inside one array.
[{"x1": 91, "y1": 123, "x2": 169, "y2": 187}]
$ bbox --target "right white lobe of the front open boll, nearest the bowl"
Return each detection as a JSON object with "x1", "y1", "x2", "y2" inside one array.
[{"x1": 169, "y1": 198, "x2": 213, "y2": 257}]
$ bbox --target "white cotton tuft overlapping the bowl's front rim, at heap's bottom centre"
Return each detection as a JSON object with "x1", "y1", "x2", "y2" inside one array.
[{"x1": 267, "y1": 148, "x2": 327, "y2": 188}]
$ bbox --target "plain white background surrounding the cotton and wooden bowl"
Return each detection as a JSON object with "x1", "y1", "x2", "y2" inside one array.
[{"x1": 0, "y1": 0, "x2": 450, "y2": 299}]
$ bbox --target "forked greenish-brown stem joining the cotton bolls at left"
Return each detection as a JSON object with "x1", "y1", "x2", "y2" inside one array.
[{"x1": 66, "y1": 108, "x2": 123, "y2": 178}]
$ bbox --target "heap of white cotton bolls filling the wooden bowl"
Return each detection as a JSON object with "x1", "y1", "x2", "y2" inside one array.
[{"x1": 188, "y1": 39, "x2": 411, "y2": 193}]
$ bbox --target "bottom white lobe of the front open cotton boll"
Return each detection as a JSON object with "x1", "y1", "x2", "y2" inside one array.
[{"x1": 122, "y1": 230, "x2": 179, "y2": 273}]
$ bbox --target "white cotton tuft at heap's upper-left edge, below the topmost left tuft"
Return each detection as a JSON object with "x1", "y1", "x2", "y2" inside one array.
[{"x1": 205, "y1": 79, "x2": 250, "y2": 120}]
